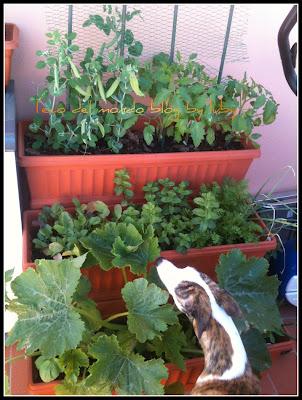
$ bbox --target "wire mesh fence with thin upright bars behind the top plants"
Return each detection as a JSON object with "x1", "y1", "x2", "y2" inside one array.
[{"x1": 45, "y1": 3, "x2": 249, "y2": 76}]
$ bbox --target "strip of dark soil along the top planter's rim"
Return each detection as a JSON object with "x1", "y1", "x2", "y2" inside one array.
[{"x1": 25, "y1": 126, "x2": 244, "y2": 156}]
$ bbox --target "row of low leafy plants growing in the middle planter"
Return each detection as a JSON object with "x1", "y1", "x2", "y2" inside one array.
[{"x1": 33, "y1": 169, "x2": 264, "y2": 260}]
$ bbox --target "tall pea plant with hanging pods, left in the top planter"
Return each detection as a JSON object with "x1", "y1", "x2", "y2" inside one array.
[{"x1": 29, "y1": 5, "x2": 145, "y2": 153}]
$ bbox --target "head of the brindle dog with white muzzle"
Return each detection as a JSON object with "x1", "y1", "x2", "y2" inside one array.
[{"x1": 156, "y1": 258, "x2": 242, "y2": 338}]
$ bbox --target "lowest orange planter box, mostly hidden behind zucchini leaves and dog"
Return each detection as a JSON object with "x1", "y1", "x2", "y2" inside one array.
[{"x1": 6, "y1": 340, "x2": 295, "y2": 396}]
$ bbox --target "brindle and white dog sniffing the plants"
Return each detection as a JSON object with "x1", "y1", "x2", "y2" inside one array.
[{"x1": 156, "y1": 258, "x2": 260, "y2": 395}]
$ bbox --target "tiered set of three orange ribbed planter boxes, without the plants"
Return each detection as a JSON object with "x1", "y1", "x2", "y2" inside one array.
[{"x1": 18, "y1": 115, "x2": 286, "y2": 395}]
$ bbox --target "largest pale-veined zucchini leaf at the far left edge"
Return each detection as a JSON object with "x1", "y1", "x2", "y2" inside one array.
[{"x1": 7, "y1": 254, "x2": 86, "y2": 358}]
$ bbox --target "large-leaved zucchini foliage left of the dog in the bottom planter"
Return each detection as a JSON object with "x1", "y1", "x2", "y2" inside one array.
[{"x1": 7, "y1": 255, "x2": 183, "y2": 395}]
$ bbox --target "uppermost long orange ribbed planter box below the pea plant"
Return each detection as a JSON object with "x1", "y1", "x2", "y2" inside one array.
[{"x1": 18, "y1": 121, "x2": 260, "y2": 209}]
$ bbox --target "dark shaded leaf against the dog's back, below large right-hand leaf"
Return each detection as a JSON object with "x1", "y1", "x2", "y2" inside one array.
[{"x1": 241, "y1": 328, "x2": 272, "y2": 372}]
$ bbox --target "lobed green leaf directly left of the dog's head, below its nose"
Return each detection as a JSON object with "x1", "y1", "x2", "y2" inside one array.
[{"x1": 122, "y1": 278, "x2": 178, "y2": 343}]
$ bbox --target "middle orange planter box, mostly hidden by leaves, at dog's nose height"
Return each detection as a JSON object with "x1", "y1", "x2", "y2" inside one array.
[{"x1": 22, "y1": 210, "x2": 277, "y2": 304}]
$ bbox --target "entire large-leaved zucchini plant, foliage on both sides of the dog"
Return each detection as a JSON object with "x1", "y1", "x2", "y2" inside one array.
[{"x1": 5, "y1": 250, "x2": 284, "y2": 395}]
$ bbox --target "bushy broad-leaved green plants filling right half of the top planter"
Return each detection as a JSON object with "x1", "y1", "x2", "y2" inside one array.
[{"x1": 139, "y1": 52, "x2": 278, "y2": 148}]
